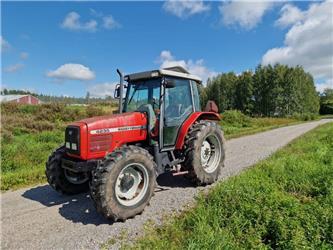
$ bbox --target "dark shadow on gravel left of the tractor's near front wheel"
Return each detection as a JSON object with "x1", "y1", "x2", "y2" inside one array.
[{"x1": 22, "y1": 185, "x2": 113, "y2": 226}]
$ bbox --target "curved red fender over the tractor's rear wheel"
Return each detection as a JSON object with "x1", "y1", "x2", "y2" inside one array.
[{"x1": 175, "y1": 112, "x2": 221, "y2": 149}]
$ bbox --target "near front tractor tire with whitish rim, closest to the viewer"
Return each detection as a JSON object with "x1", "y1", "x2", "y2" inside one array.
[{"x1": 90, "y1": 146, "x2": 156, "y2": 221}]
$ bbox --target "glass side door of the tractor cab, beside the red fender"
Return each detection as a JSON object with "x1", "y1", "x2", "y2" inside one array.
[{"x1": 162, "y1": 78, "x2": 194, "y2": 148}]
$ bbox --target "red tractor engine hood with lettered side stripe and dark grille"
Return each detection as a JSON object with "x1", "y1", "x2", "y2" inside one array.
[{"x1": 66, "y1": 112, "x2": 147, "y2": 160}]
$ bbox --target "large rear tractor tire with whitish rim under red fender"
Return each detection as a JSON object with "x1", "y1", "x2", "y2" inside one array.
[{"x1": 183, "y1": 120, "x2": 225, "y2": 185}]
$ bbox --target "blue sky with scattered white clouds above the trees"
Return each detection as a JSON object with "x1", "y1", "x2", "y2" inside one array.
[{"x1": 1, "y1": 1, "x2": 333, "y2": 96}]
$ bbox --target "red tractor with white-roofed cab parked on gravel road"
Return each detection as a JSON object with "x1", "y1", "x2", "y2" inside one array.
[{"x1": 46, "y1": 67, "x2": 225, "y2": 221}]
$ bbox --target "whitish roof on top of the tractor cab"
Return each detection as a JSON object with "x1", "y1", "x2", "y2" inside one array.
[{"x1": 125, "y1": 66, "x2": 202, "y2": 84}]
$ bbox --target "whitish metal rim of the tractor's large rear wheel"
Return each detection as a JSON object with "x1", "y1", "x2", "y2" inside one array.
[{"x1": 200, "y1": 134, "x2": 221, "y2": 173}]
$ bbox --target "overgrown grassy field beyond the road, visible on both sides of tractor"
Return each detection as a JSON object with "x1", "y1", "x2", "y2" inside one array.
[{"x1": 1, "y1": 104, "x2": 306, "y2": 190}]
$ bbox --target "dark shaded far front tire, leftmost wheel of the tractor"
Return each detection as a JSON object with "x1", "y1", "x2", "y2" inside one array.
[{"x1": 45, "y1": 146, "x2": 89, "y2": 195}]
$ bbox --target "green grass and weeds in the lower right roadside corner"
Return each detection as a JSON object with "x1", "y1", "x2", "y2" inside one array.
[{"x1": 126, "y1": 123, "x2": 333, "y2": 249}]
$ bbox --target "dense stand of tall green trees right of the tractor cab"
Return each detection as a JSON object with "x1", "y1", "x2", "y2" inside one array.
[{"x1": 201, "y1": 64, "x2": 319, "y2": 116}]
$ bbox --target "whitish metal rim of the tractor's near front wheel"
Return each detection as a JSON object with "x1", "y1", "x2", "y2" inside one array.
[{"x1": 115, "y1": 163, "x2": 148, "y2": 207}]
